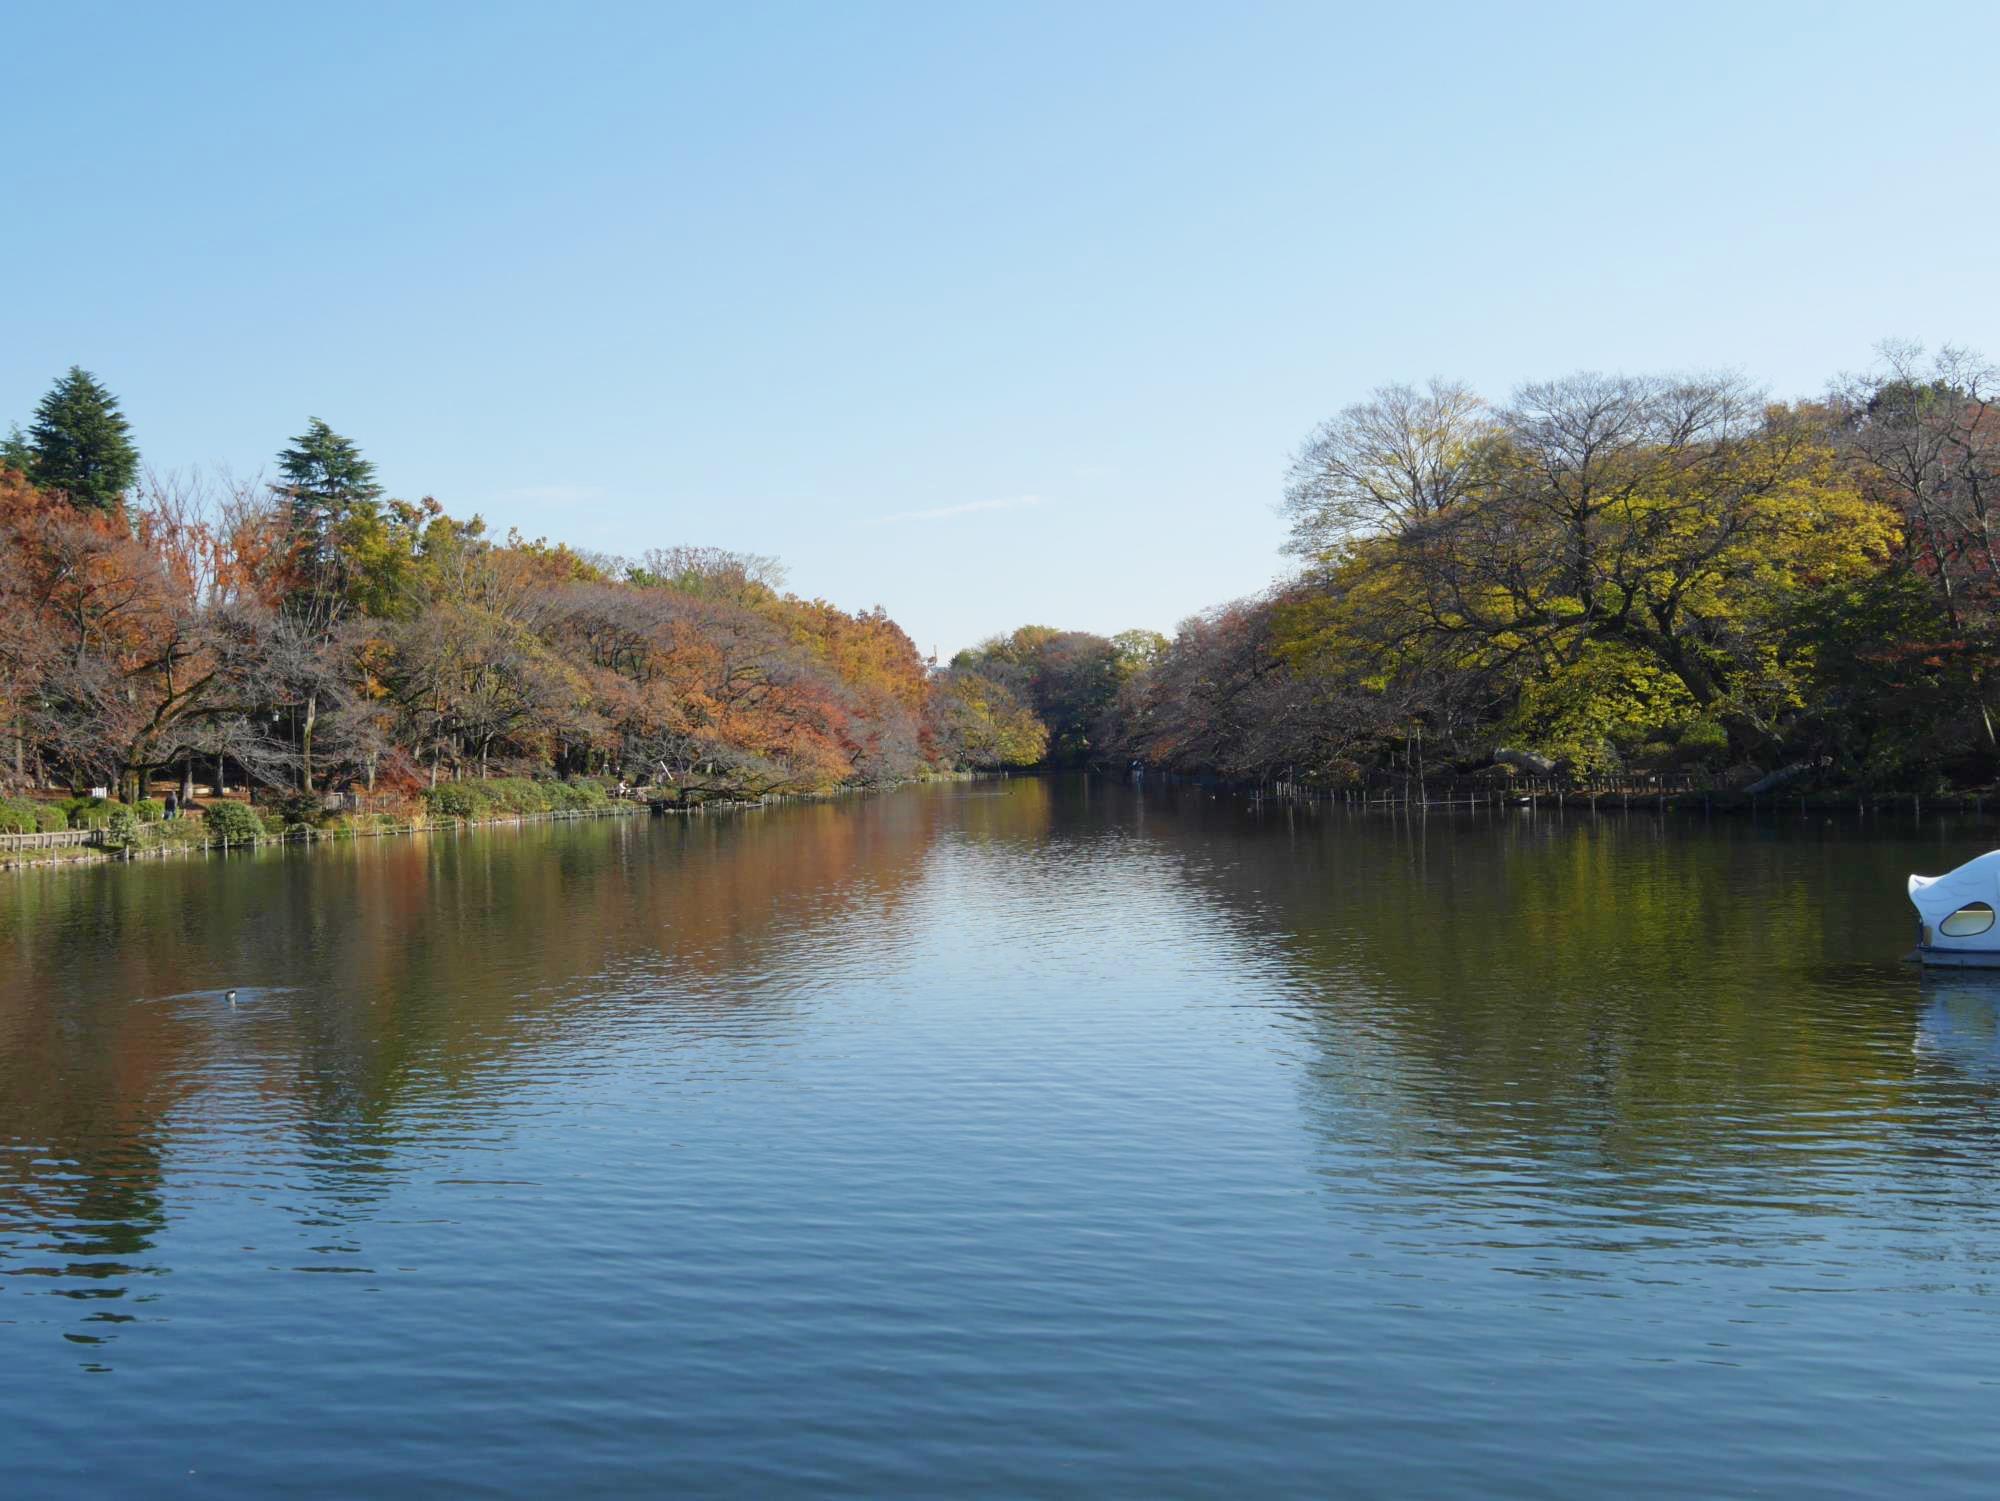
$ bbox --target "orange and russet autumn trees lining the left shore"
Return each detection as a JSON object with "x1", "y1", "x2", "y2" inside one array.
[{"x1": 0, "y1": 382, "x2": 1044, "y2": 804}]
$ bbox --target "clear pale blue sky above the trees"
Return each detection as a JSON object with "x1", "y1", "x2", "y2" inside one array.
[{"x1": 0, "y1": 2, "x2": 2000, "y2": 652}]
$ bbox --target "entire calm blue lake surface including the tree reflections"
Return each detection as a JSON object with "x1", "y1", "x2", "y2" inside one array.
[{"x1": 0, "y1": 781, "x2": 2000, "y2": 1497}]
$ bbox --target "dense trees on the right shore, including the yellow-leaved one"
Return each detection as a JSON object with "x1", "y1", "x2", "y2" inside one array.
[{"x1": 976, "y1": 348, "x2": 2000, "y2": 791}]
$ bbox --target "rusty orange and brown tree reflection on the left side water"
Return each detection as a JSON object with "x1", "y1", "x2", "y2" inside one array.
[{"x1": 0, "y1": 783, "x2": 1048, "y2": 1339}]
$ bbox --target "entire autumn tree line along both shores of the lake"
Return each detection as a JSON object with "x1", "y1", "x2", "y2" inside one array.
[{"x1": 0, "y1": 346, "x2": 2000, "y2": 864}]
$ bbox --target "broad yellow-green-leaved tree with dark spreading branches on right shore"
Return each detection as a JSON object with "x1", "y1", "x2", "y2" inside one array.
[{"x1": 1280, "y1": 374, "x2": 1892, "y2": 755}]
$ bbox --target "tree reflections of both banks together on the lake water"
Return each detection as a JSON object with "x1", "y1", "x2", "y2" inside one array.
[{"x1": 11, "y1": 779, "x2": 2000, "y2": 1376}]
